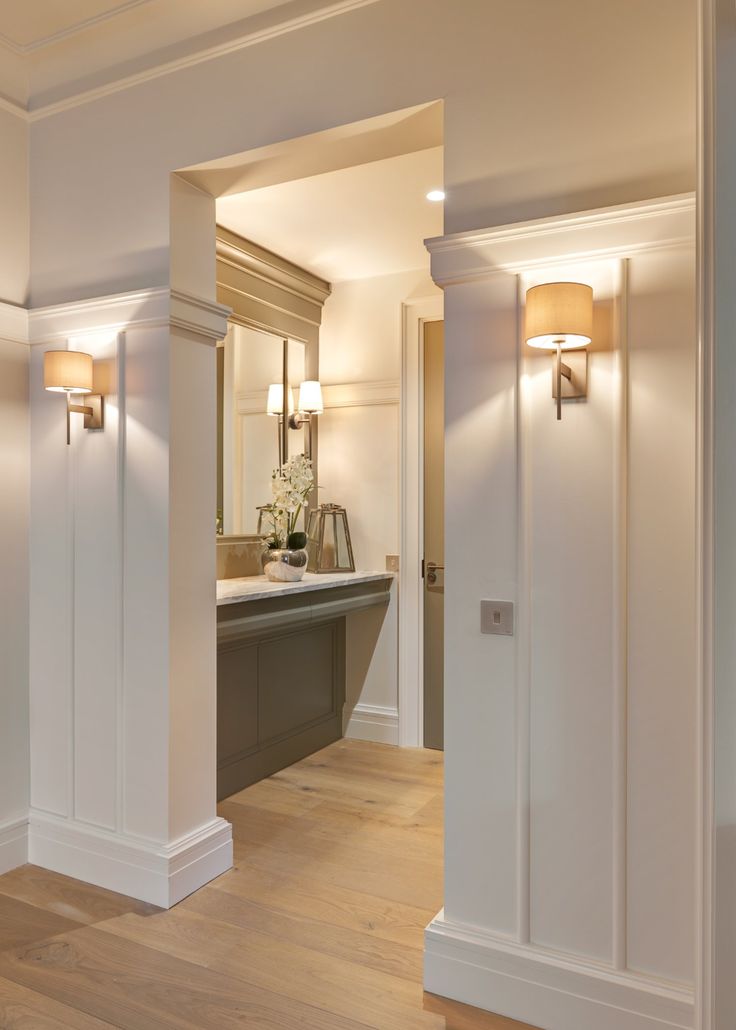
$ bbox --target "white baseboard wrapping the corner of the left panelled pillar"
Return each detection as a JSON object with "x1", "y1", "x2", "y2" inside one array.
[{"x1": 28, "y1": 811, "x2": 233, "y2": 908}]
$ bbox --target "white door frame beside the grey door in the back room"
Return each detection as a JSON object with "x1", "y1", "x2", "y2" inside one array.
[{"x1": 398, "y1": 294, "x2": 445, "y2": 748}]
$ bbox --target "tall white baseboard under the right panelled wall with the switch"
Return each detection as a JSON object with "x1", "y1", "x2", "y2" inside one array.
[{"x1": 424, "y1": 913, "x2": 695, "y2": 1030}]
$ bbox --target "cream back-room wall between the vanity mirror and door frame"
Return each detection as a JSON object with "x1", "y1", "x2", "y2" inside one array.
[{"x1": 319, "y1": 269, "x2": 440, "y2": 744}]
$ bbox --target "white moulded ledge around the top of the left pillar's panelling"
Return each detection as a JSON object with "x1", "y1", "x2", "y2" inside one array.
[{"x1": 28, "y1": 286, "x2": 230, "y2": 344}]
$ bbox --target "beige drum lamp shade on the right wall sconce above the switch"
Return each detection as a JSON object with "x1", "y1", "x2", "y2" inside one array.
[{"x1": 526, "y1": 282, "x2": 593, "y2": 350}]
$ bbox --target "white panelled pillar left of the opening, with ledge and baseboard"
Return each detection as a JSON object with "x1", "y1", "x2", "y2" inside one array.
[{"x1": 28, "y1": 289, "x2": 232, "y2": 906}]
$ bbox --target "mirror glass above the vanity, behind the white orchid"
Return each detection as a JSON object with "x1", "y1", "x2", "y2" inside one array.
[{"x1": 217, "y1": 322, "x2": 307, "y2": 536}]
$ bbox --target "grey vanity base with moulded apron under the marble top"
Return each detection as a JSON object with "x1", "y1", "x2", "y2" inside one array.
[{"x1": 217, "y1": 577, "x2": 391, "y2": 801}]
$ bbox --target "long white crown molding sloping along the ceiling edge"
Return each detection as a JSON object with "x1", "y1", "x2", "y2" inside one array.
[{"x1": 26, "y1": 0, "x2": 381, "y2": 123}]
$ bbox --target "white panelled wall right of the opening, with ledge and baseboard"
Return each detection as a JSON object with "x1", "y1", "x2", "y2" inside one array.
[{"x1": 426, "y1": 198, "x2": 699, "y2": 1030}]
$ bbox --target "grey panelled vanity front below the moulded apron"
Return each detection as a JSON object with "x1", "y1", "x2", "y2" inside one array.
[{"x1": 217, "y1": 616, "x2": 345, "y2": 800}]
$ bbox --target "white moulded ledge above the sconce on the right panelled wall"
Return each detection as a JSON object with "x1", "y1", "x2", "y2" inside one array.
[{"x1": 425, "y1": 194, "x2": 696, "y2": 286}]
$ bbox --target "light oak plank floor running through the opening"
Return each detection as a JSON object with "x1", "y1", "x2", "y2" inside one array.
[{"x1": 0, "y1": 741, "x2": 535, "y2": 1030}]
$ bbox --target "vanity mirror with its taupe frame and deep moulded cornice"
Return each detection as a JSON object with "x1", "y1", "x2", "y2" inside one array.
[{"x1": 216, "y1": 226, "x2": 330, "y2": 551}]
